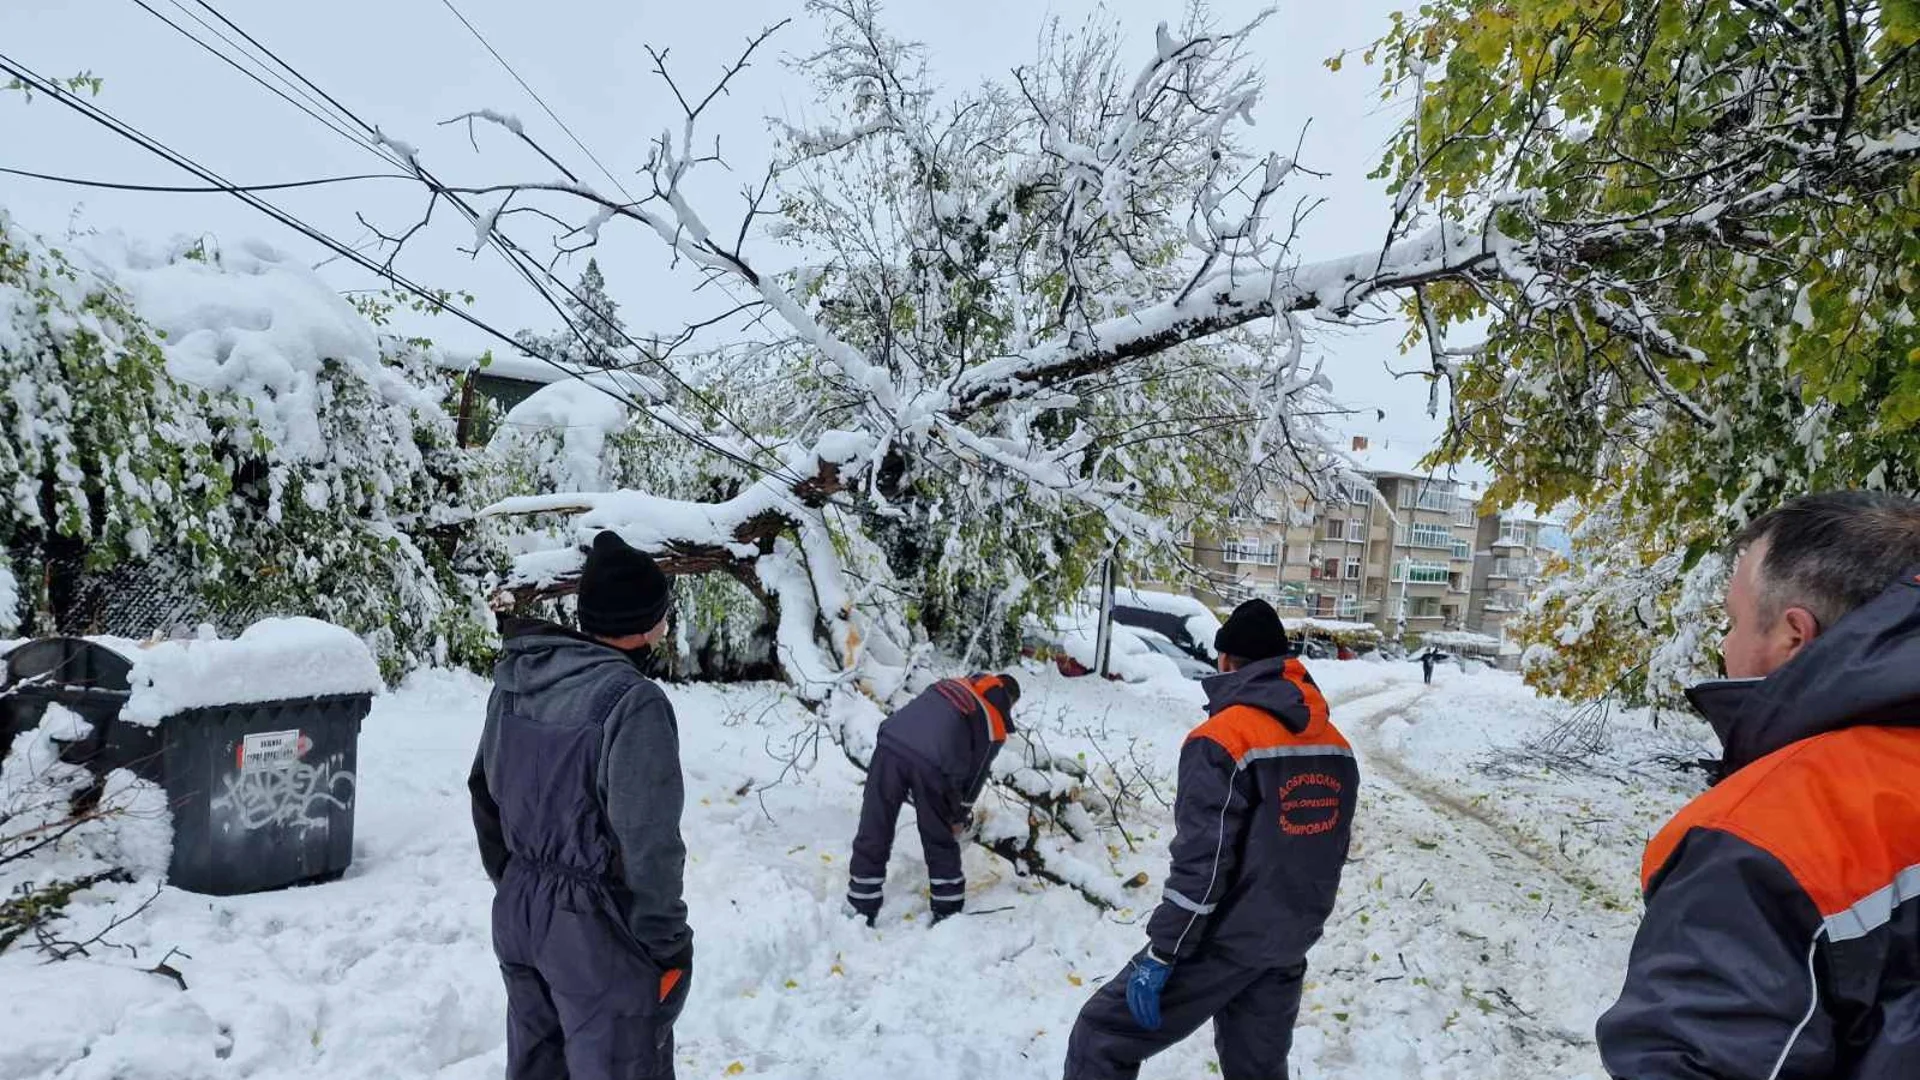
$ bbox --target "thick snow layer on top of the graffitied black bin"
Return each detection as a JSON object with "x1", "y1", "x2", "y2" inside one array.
[{"x1": 121, "y1": 619, "x2": 386, "y2": 726}]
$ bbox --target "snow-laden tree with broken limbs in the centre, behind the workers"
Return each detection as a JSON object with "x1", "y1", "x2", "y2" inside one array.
[{"x1": 416, "y1": 2, "x2": 1382, "y2": 688}]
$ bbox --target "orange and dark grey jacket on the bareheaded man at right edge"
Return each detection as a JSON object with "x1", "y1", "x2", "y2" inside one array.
[{"x1": 1599, "y1": 577, "x2": 1920, "y2": 1080}]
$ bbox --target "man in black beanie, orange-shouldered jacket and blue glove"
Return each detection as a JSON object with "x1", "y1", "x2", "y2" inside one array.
[{"x1": 1066, "y1": 600, "x2": 1359, "y2": 1080}]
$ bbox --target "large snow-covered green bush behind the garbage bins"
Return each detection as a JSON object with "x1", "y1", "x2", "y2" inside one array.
[{"x1": 0, "y1": 215, "x2": 488, "y2": 675}]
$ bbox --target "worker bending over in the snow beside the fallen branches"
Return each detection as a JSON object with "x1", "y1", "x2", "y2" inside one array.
[{"x1": 847, "y1": 675, "x2": 1020, "y2": 926}]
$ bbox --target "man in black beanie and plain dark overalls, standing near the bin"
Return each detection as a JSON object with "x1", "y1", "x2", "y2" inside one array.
[{"x1": 467, "y1": 532, "x2": 693, "y2": 1080}]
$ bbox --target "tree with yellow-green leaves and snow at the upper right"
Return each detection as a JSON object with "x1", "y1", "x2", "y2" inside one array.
[{"x1": 1377, "y1": 0, "x2": 1920, "y2": 701}]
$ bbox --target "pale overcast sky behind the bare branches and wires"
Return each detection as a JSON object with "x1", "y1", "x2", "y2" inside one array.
[{"x1": 0, "y1": 0, "x2": 1438, "y2": 446}]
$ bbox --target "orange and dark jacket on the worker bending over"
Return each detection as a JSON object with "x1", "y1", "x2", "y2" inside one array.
[{"x1": 879, "y1": 675, "x2": 1014, "y2": 822}]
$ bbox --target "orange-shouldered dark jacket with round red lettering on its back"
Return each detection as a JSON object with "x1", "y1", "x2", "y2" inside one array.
[{"x1": 1146, "y1": 657, "x2": 1359, "y2": 969}]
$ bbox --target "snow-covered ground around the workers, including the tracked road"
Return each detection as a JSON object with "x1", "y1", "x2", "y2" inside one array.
[{"x1": 0, "y1": 661, "x2": 1712, "y2": 1080}]
